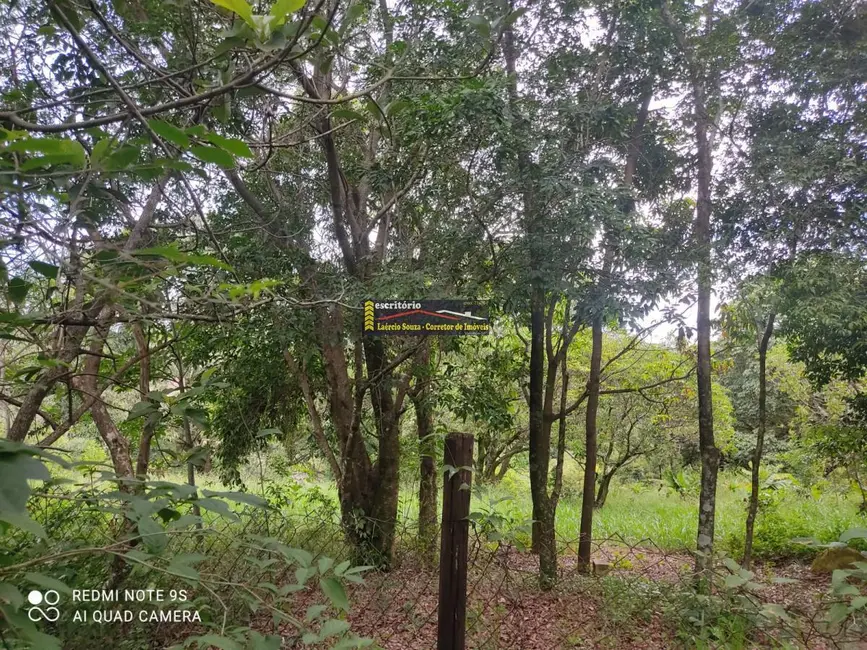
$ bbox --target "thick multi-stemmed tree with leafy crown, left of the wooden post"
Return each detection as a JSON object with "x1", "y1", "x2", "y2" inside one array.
[{"x1": 179, "y1": 4, "x2": 496, "y2": 566}]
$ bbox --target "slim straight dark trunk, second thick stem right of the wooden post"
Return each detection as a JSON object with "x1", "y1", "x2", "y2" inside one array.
[{"x1": 578, "y1": 314, "x2": 602, "y2": 572}]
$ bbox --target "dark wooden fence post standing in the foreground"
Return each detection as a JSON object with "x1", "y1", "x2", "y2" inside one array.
[{"x1": 437, "y1": 433, "x2": 473, "y2": 650}]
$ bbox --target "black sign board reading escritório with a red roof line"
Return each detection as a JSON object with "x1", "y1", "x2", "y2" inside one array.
[{"x1": 362, "y1": 300, "x2": 491, "y2": 336}]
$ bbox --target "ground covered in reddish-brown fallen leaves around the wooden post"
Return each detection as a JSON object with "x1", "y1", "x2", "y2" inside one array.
[{"x1": 274, "y1": 547, "x2": 867, "y2": 650}]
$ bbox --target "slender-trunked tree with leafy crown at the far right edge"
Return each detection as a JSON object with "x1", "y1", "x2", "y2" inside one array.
[{"x1": 719, "y1": 1, "x2": 864, "y2": 566}]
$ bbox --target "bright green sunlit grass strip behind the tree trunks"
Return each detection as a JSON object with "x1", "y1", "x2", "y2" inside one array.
[{"x1": 49, "y1": 444, "x2": 867, "y2": 559}]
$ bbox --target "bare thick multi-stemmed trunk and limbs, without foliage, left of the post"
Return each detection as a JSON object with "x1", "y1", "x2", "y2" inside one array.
[{"x1": 284, "y1": 17, "x2": 403, "y2": 567}]
